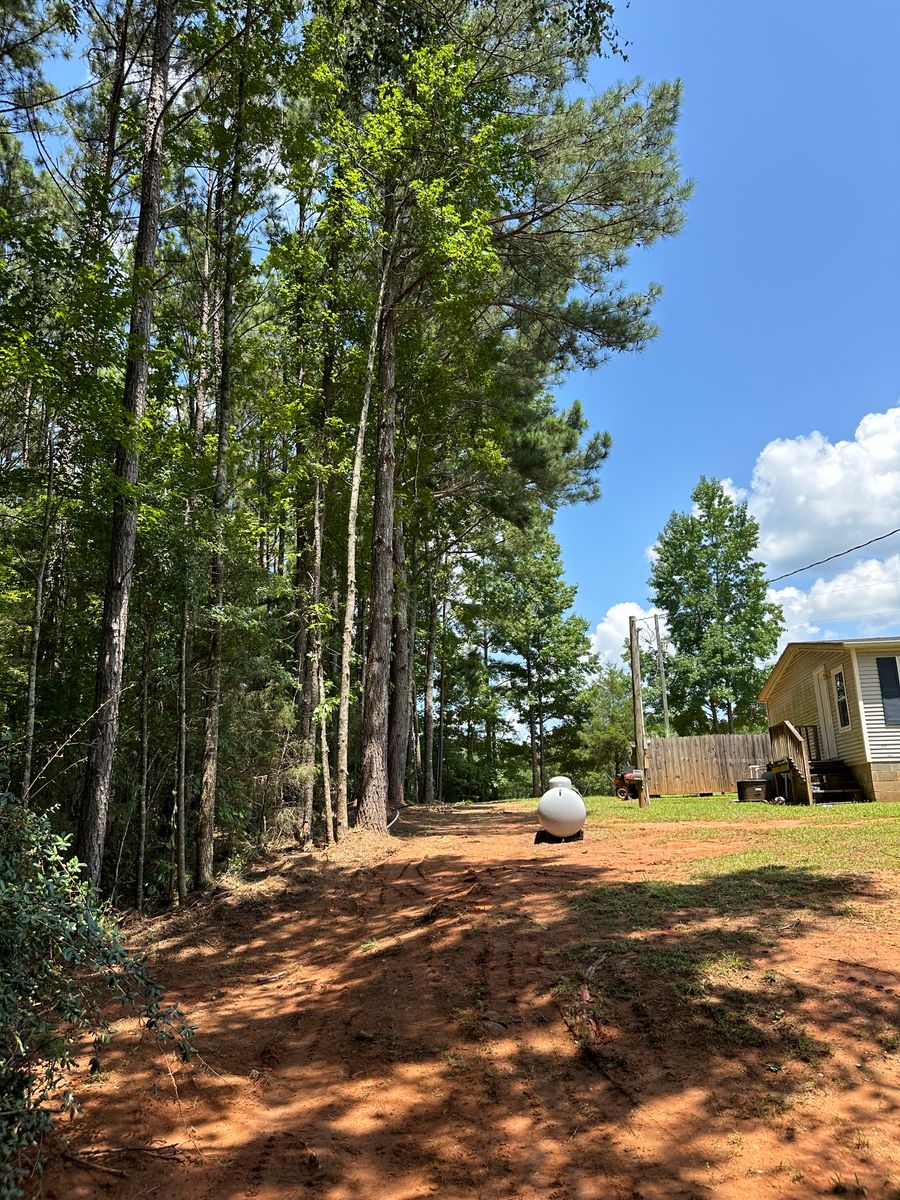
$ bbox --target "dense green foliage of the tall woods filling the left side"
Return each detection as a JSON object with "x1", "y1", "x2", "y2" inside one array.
[{"x1": 0, "y1": 0, "x2": 689, "y2": 873}]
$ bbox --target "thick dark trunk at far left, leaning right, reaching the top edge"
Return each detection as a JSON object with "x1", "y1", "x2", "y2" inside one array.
[{"x1": 76, "y1": 0, "x2": 175, "y2": 884}]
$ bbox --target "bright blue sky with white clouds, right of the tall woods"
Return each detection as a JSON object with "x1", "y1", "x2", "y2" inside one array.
[{"x1": 556, "y1": 0, "x2": 900, "y2": 650}]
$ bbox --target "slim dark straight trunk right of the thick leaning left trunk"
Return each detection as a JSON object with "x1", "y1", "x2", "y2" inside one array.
[{"x1": 197, "y1": 32, "x2": 250, "y2": 888}]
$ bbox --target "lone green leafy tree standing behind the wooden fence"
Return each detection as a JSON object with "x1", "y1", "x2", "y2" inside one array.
[{"x1": 650, "y1": 478, "x2": 784, "y2": 733}]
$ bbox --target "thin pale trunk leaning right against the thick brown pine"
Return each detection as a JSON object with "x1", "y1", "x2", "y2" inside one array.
[{"x1": 337, "y1": 238, "x2": 392, "y2": 839}]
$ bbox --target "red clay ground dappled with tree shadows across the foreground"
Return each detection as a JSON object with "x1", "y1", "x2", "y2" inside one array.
[{"x1": 34, "y1": 808, "x2": 900, "y2": 1200}]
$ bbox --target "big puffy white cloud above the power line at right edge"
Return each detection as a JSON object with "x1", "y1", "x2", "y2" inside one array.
[{"x1": 749, "y1": 407, "x2": 900, "y2": 572}]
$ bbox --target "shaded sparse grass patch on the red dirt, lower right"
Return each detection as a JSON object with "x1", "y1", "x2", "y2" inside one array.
[{"x1": 554, "y1": 859, "x2": 868, "y2": 1089}]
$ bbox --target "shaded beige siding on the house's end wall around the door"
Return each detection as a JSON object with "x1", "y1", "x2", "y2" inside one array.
[{"x1": 766, "y1": 643, "x2": 868, "y2": 763}]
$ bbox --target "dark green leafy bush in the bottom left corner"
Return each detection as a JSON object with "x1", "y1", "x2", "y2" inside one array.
[{"x1": 0, "y1": 793, "x2": 194, "y2": 1200}]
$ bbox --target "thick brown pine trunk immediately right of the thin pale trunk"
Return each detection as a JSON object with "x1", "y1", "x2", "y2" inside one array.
[{"x1": 359, "y1": 283, "x2": 397, "y2": 833}]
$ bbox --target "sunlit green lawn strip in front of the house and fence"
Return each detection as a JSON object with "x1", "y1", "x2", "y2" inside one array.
[{"x1": 586, "y1": 796, "x2": 900, "y2": 875}]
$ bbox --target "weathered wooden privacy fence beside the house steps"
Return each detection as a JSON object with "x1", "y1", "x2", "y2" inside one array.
[{"x1": 647, "y1": 733, "x2": 772, "y2": 796}]
